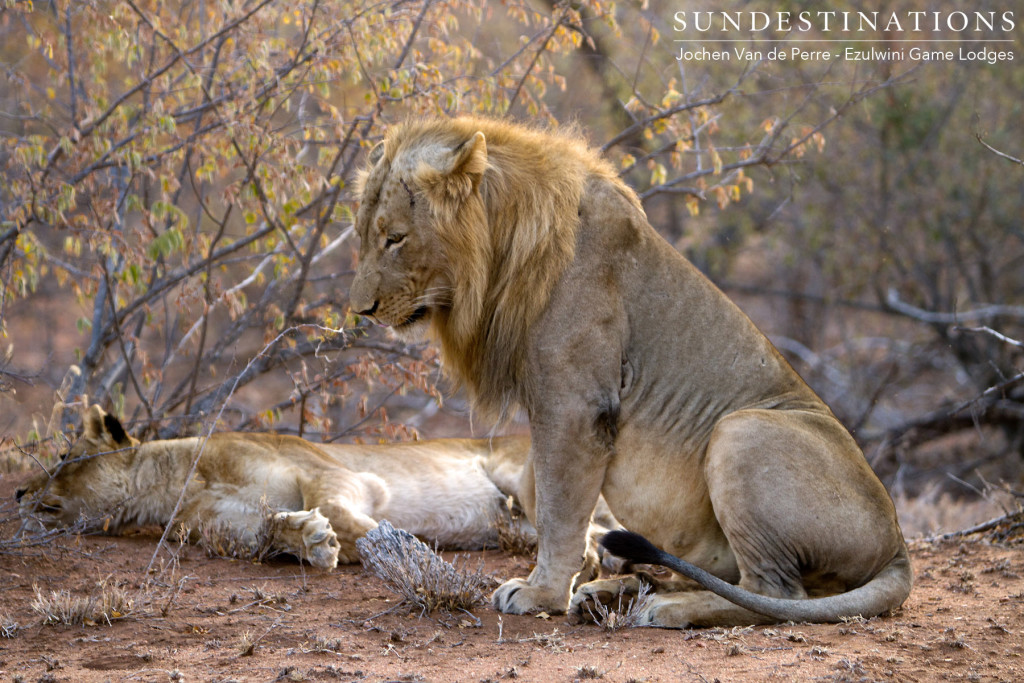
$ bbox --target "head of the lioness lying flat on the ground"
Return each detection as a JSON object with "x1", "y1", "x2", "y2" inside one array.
[{"x1": 15, "y1": 405, "x2": 138, "y2": 531}]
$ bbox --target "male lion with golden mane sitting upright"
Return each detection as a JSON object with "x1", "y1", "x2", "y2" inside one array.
[{"x1": 351, "y1": 118, "x2": 911, "y2": 627}]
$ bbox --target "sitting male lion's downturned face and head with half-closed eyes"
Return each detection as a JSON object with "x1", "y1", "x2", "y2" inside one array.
[{"x1": 351, "y1": 123, "x2": 489, "y2": 338}]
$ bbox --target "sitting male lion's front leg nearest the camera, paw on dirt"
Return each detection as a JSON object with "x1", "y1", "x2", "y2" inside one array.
[{"x1": 492, "y1": 413, "x2": 608, "y2": 614}]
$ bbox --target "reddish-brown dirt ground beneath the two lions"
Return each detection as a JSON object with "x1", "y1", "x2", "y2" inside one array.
[{"x1": 0, "y1": 475, "x2": 1024, "y2": 683}]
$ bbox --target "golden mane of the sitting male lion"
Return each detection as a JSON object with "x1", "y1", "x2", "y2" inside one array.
[{"x1": 360, "y1": 118, "x2": 639, "y2": 417}]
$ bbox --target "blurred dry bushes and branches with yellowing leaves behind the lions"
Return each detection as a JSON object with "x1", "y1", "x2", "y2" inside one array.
[{"x1": 0, "y1": 0, "x2": 1024, "y2": 524}]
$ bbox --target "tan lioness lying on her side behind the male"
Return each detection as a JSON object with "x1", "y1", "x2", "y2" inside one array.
[{"x1": 16, "y1": 405, "x2": 616, "y2": 575}]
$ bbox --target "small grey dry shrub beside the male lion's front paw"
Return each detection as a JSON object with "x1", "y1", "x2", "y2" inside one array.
[{"x1": 355, "y1": 520, "x2": 490, "y2": 612}]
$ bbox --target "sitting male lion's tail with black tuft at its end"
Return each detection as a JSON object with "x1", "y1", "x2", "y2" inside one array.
[{"x1": 601, "y1": 530, "x2": 913, "y2": 623}]
